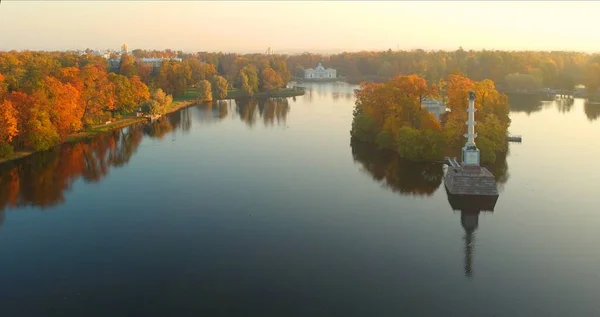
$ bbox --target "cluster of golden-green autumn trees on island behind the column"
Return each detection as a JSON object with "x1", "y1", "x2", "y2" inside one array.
[{"x1": 351, "y1": 75, "x2": 510, "y2": 163}]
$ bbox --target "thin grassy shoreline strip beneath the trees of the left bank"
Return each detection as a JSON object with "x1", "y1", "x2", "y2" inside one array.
[{"x1": 0, "y1": 88, "x2": 305, "y2": 166}]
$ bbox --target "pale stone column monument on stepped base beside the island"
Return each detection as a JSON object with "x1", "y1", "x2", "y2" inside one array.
[{"x1": 444, "y1": 91, "x2": 498, "y2": 196}]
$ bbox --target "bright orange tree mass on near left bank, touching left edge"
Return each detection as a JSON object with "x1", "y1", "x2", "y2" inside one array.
[{"x1": 0, "y1": 52, "x2": 156, "y2": 157}]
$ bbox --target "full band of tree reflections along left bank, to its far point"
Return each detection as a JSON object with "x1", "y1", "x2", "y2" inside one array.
[{"x1": 0, "y1": 98, "x2": 290, "y2": 215}]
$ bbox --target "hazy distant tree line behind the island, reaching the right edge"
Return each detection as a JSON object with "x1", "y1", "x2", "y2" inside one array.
[{"x1": 288, "y1": 48, "x2": 600, "y2": 91}]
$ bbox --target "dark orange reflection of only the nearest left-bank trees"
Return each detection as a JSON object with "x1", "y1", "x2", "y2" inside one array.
[{"x1": 0, "y1": 124, "x2": 144, "y2": 212}]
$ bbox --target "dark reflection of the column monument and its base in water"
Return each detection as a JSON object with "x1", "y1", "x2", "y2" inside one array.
[{"x1": 446, "y1": 190, "x2": 498, "y2": 277}]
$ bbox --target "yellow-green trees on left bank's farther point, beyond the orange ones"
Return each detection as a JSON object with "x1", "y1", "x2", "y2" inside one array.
[{"x1": 113, "y1": 50, "x2": 290, "y2": 101}]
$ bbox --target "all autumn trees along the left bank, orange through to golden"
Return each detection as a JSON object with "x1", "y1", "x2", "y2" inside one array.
[{"x1": 0, "y1": 51, "x2": 301, "y2": 160}]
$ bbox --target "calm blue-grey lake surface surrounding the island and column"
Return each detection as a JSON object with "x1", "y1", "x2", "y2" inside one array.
[{"x1": 0, "y1": 83, "x2": 600, "y2": 317}]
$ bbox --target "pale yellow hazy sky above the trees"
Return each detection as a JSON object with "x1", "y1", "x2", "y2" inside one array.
[{"x1": 0, "y1": 0, "x2": 600, "y2": 52}]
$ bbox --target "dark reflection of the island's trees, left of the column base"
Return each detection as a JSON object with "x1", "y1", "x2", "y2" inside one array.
[{"x1": 350, "y1": 141, "x2": 444, "y2": 196}]
